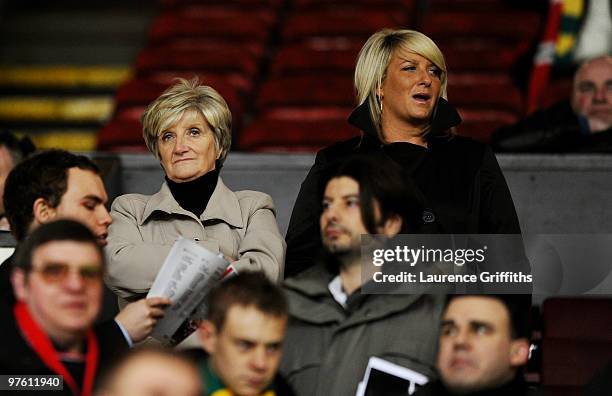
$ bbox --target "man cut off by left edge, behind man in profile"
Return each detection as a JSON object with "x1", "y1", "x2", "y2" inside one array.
[{"x1": 0, "y1": 130, "x2": 36, "y2": 231}]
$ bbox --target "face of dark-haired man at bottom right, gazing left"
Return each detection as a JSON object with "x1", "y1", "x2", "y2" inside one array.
[{"x1": 437, "y1": 296, "x2": 529, "y2": 394}]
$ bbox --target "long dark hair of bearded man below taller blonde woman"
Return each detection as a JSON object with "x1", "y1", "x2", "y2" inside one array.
[{"x1": 322, "y1": 155, "x2": 424, "y2": 234}]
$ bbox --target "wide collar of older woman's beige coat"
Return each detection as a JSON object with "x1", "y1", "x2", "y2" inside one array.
[{"x1": 139, "y1": 177, "x2": 244, "y2": 228}]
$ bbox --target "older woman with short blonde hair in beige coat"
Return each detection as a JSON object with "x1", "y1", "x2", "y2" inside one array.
[{"x1": 106, "y1": 79, "x2": 285, "y2": 302}]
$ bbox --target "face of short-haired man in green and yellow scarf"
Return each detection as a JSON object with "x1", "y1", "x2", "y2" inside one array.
[{"x1": 200, "y1": 305, "x2": 287, "y2": 396}]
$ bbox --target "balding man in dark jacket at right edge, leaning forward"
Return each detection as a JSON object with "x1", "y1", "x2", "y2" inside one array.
[{"x1": 491, "y1": 55, "x2": 612, "y2": 153}]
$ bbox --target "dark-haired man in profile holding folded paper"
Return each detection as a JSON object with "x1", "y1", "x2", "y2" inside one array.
[{"x1": 0, "y1": 150, "x2": 169, "y2": 345}]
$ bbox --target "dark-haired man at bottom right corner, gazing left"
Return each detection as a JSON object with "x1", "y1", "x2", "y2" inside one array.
[{"x1": 417, "y1": 294, "x2": 531, "y2": 396}]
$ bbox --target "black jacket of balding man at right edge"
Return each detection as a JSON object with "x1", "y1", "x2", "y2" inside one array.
[{"x1": 491, "y1": 100, "x2": 612, "y2": 153}]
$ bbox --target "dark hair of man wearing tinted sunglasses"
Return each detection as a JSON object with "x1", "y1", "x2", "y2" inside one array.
[{"x1": 13, "y1": 220, "x2": 104, "y2": 271}]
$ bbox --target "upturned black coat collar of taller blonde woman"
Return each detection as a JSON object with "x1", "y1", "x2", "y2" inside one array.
[{"x1": 348, "y1": 98, "x2": 461, "y2": 145}]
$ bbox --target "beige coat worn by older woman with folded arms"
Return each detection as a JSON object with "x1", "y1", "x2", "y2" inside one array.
[{"x1": 105, "y1": 178, "x2": 285, "y2": 305}]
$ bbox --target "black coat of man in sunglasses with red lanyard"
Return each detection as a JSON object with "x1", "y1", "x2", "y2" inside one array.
[{"x1": 0, "y1": 301, "x2": 129, "y2": 396}]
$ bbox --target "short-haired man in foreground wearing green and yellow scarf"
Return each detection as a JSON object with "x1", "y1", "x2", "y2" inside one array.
[{"x1": 200, "y1": 272, "x2": 291, "y2": 396}]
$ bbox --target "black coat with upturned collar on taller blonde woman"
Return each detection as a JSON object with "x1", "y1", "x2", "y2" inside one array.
[{"x1": 285, "y1": 99, "x2": 520, "y2": 277}]
